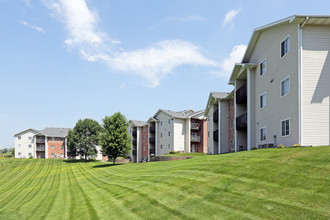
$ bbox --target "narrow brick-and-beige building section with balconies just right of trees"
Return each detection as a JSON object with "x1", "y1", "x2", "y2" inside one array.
[{"x1": 128, "y1": 120, "x2": 150, "y2": 163}]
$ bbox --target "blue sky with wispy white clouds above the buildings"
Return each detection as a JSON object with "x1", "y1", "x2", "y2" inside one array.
[{"x1": 0, "y1": 0, "x2": 330, "y2": 148}]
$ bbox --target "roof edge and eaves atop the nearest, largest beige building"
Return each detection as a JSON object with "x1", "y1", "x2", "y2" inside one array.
[{"x1": 242, "y1": 15, "x2": 330, "y2": 63}]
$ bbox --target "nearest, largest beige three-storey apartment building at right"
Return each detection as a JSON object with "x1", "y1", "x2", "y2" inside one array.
[{"x1": 229, "y1": 15, "x2": 330, "y2": 151}]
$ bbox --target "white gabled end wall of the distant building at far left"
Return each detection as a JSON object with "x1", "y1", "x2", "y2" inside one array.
[{"x1": 15, "y1": 130, "x2": 37, "y2": 158}]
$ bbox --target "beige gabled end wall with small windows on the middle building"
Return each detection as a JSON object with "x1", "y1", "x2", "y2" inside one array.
[{"x1": 156, "y1": 112, "x2": 174, "y2": 156}]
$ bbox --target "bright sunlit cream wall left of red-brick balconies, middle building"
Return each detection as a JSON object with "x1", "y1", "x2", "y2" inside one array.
[{"x1": 173, "y1": 118, "x2": 189, "y2": 151}]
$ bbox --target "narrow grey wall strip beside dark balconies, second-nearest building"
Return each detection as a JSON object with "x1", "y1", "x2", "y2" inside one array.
[{"x1": 218, "y1": 100, "x2": 229, "y2": 153}]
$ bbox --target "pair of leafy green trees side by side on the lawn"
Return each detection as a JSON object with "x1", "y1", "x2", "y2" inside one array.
[{"x1": 67, "y1": 112, "x2": 131, "y2": 164}]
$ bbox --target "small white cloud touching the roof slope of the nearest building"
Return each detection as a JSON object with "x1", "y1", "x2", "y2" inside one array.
[{"x1": 211, "y1": 44, "x2": 246, "y2": 79}]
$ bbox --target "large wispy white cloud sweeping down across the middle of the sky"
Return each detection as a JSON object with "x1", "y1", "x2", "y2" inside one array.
[{"x1": 42, "y1": 0, "x2": 217, "y2": 87}]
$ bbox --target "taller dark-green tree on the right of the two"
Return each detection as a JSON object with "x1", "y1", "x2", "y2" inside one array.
[{"x1": 99, "y1": 112, "x2": 131, "y2": 164}]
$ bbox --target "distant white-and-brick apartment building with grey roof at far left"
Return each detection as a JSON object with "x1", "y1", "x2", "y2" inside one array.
[{"x1": 14, "y1": 128, "x2": 69, "y2": 159}]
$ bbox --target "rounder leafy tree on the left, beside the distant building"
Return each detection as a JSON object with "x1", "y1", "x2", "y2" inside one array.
[{"x1": 67, "y1": 118, "x2": 102, "y2": 161}]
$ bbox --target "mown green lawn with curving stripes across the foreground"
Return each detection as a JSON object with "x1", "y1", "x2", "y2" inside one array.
[{"x1": 0, "y1": 147, "x2": 330, "y2": 220}]
